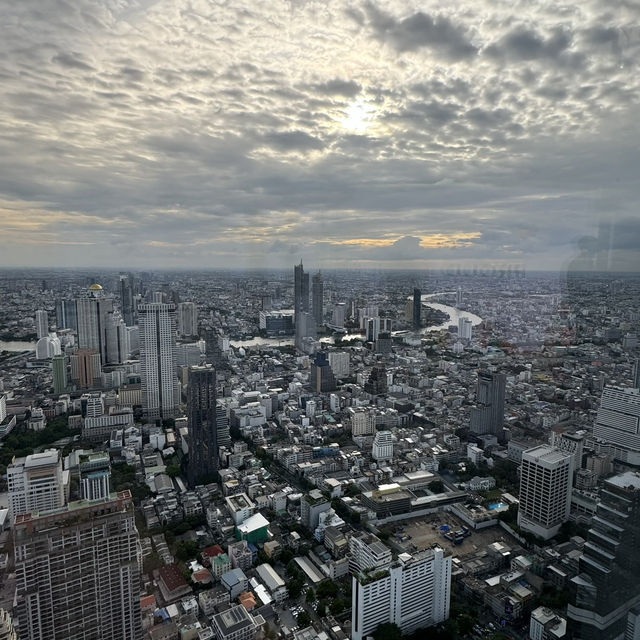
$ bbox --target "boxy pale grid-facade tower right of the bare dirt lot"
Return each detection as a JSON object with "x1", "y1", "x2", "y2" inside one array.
[{"x1": 518, "y1": 445, "x2": 573, "y2": 540}]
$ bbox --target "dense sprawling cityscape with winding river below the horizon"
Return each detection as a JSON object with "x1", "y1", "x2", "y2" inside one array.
[{"x1": 0, "y1": 261, "x2": 640, "y2": 640}]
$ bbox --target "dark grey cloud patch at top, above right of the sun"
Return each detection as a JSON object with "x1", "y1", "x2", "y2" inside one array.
[{"x1": 367, "y1": 4, "x2": 477, "y2": 60}]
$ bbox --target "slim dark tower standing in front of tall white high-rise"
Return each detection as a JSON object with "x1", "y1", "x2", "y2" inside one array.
[{"x1": 187, "y1": 367, "x2": 218, "y2": 487}]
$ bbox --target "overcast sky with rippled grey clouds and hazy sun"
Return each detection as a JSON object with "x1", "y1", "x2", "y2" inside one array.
[{"x1": 0, "y1": 0, "x2": 640, "y2": 270}]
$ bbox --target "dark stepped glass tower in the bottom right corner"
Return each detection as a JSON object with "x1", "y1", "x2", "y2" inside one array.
[{"x1": 567, "y1": 471, "x2": 640, "y2": 640}]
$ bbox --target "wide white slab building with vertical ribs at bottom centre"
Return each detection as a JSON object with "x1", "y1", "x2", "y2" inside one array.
[{"x1": 351, "y1": 547, "x2": 451, "y2": 640}]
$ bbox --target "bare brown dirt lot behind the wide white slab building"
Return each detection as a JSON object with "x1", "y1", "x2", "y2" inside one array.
[{"x1": 385, "y1": 512, "x2": 518, "y2": 557}]
